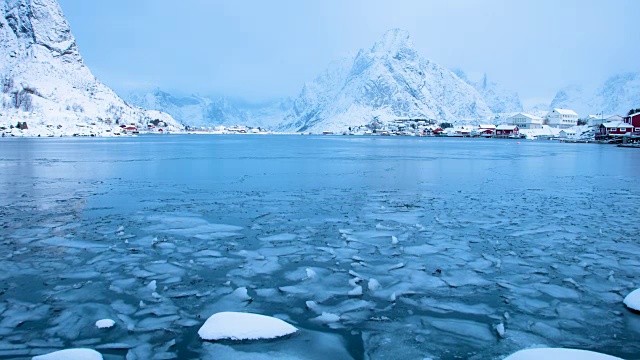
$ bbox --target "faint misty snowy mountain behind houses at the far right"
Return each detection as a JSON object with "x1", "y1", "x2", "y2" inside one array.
[{"x1": 550, "y1": 72, "x2": 640, "y2": 117}]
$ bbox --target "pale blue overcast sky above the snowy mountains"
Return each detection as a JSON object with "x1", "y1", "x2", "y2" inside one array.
[{"x1": 58, "y1": 0, "x2": 640, "y2": 106}]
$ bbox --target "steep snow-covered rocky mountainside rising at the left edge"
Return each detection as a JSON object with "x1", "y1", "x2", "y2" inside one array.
[{"x1": 0, "y1": 0, "x2": 182, "y2": 132}]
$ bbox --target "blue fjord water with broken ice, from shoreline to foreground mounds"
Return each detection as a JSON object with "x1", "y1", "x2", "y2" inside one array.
[{"x1": 0, "y1": 136, "x2": 640, "y2": 360}]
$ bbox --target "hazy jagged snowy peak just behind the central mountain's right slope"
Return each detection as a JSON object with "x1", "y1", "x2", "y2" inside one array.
[{"x1": 453, "y1": 69, "x2": 523, "y2": 114}]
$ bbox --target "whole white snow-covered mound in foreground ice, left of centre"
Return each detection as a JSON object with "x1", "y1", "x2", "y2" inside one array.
[{"x1": 198, "y1": 312, "x2": 298, "y2": 340}]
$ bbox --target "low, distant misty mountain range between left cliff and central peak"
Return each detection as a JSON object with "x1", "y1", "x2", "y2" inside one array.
[{"x1": 128, "y1": 90, "x2": 292, "y2": 128}]
